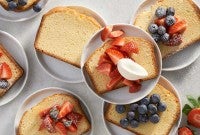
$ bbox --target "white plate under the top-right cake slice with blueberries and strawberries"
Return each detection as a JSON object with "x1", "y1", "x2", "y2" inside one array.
[{"x1": 130, "y1": 0, "x2": 200, "y2": 71}]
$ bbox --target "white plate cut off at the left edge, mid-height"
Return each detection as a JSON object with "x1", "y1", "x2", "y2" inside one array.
[{"x1": 0, "y1": 31, "x2": 28, "y2": 106}]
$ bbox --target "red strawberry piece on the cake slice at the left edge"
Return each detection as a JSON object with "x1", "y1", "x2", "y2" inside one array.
[{"x1": 0, "y1": 62, "x2": 12, "y2": 79}]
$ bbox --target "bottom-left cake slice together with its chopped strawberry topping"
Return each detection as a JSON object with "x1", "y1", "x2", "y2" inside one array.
[{"x1": 18, "y1": 94, "x2": 91, "y2": 135}]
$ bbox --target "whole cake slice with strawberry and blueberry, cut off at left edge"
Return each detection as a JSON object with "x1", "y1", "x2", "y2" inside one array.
[{"x1": 0, "y1": 44, "x2": 23, "y2": 97}]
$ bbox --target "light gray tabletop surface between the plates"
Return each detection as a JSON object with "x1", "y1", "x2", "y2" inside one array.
[{"x1": 0, "y1": 0, "x2": 200, "y2": 135}]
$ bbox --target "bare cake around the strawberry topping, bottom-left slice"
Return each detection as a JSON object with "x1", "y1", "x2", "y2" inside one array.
[{"x1": 18, "y1": 94, "x2": 91, "y2": 135}]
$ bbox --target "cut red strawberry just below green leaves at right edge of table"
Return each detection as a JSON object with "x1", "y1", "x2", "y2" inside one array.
[{"x1": 187, "y1": 108, "x2": 200, "y2": 128}]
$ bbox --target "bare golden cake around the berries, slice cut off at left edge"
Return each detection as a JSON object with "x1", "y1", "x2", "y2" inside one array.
[{"x1": 0, "y1": 44, "x2": 23, "y2": 97}]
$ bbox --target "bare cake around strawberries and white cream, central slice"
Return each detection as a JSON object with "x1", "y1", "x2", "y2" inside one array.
[{"x1": 84, "y1": 37, "x2": 158, "y2": 94}]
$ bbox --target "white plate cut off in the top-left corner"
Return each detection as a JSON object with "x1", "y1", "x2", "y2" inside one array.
[{"x1": 0, "y1": 0, "x2": 48, "y2": 22}]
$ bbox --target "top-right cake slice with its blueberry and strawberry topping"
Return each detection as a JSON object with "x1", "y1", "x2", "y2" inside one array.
[{"x1": 133, "y1": 0, "x2": 200, "y2": 58}]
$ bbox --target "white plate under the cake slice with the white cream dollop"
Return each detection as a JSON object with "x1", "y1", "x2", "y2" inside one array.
[{"x1": 81, "y1": 24, "x2": 162, "y2": 104}]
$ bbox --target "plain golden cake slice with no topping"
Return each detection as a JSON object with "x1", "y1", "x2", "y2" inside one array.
[{"x1": 35, "y1": 7, "x2": 101, "y2": 68}]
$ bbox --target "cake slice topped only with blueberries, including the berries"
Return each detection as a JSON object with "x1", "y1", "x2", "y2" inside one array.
[{"x1": 104, "y1": 84, "x2": 181, "y2": 135}]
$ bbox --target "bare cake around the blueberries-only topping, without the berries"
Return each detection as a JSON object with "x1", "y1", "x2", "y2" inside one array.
[{"x1": 105, "y1": 84, "x2": 180, "y2": 135}]
